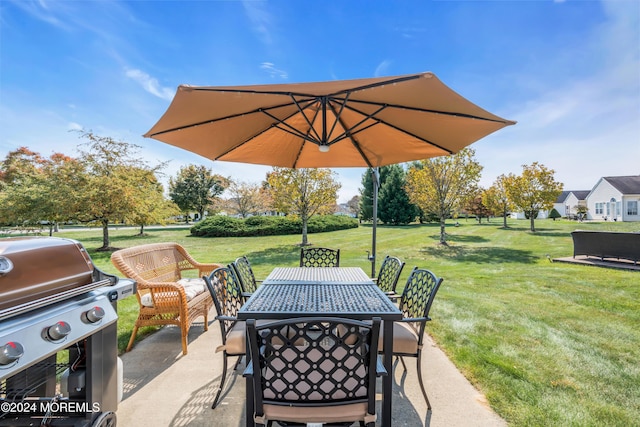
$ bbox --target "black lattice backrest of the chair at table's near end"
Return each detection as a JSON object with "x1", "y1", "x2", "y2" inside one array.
[{"x1": 247, "y1": 318, "x2": 380, "y2": 415}]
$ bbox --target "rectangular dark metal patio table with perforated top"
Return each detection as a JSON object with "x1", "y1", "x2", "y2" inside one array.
[{"x1": 238, "y1": 267, "x2": 402, "y2": 427}]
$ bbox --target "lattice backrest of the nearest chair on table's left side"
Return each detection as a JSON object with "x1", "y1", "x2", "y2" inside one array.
[{"x1": 204, "y1": 267, "x2": 244, "y2": 336}]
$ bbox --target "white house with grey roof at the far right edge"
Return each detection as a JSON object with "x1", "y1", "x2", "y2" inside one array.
[{"x1": 587, "y1": 175, "x2": 640, "y2": 221}]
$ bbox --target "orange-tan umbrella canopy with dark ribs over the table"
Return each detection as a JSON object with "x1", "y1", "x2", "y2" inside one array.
[{"x1": 144, "y1": 73, "x2": 515, "y2": 168}]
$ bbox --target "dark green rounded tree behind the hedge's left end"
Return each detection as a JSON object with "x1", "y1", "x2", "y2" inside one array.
[{"x1": 169, "y1": 165, "x2": 228, "y2": 224}]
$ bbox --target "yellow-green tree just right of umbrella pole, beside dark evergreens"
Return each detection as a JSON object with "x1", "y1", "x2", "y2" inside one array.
[{"x1": 406, "y1": 148, "x2": 482, "y2": 245}]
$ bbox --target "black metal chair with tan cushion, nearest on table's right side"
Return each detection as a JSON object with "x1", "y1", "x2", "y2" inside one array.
[{"x1": 378, "y1": 267, "x2": 443, "y2": 410}]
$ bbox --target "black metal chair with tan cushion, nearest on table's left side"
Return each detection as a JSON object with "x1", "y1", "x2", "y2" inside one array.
[{"x1": 204, "y1": 267, "x2": 247, "y2": 409}]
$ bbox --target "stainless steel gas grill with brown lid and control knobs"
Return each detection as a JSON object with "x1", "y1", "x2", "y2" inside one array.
[{"x1": 0, "y1": 238, "x2": 135, "y2": 427}]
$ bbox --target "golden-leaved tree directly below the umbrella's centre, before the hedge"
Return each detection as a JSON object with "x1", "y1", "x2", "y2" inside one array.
[{"x1": 267, "y1": 167, "x2": 340, "y2": 246}]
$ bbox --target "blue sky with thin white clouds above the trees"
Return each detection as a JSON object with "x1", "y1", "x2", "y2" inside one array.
[{"x1": 0, "y1": 0, "x2": 640, "y2": 201}]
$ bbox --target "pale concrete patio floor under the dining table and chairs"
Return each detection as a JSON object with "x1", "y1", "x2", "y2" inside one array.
[{"x1": 117, "y1": 313, "x2": 506, "y2": 427}]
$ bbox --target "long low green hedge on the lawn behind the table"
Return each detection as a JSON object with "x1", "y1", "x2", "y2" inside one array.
[{"x1": 191, "y1": 215, "x2": 358, "y2": 237}]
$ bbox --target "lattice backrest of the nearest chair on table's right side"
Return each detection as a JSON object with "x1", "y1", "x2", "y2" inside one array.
[{"x1": 399, "y1": 267, "x2": 442, "y2": 337}]
